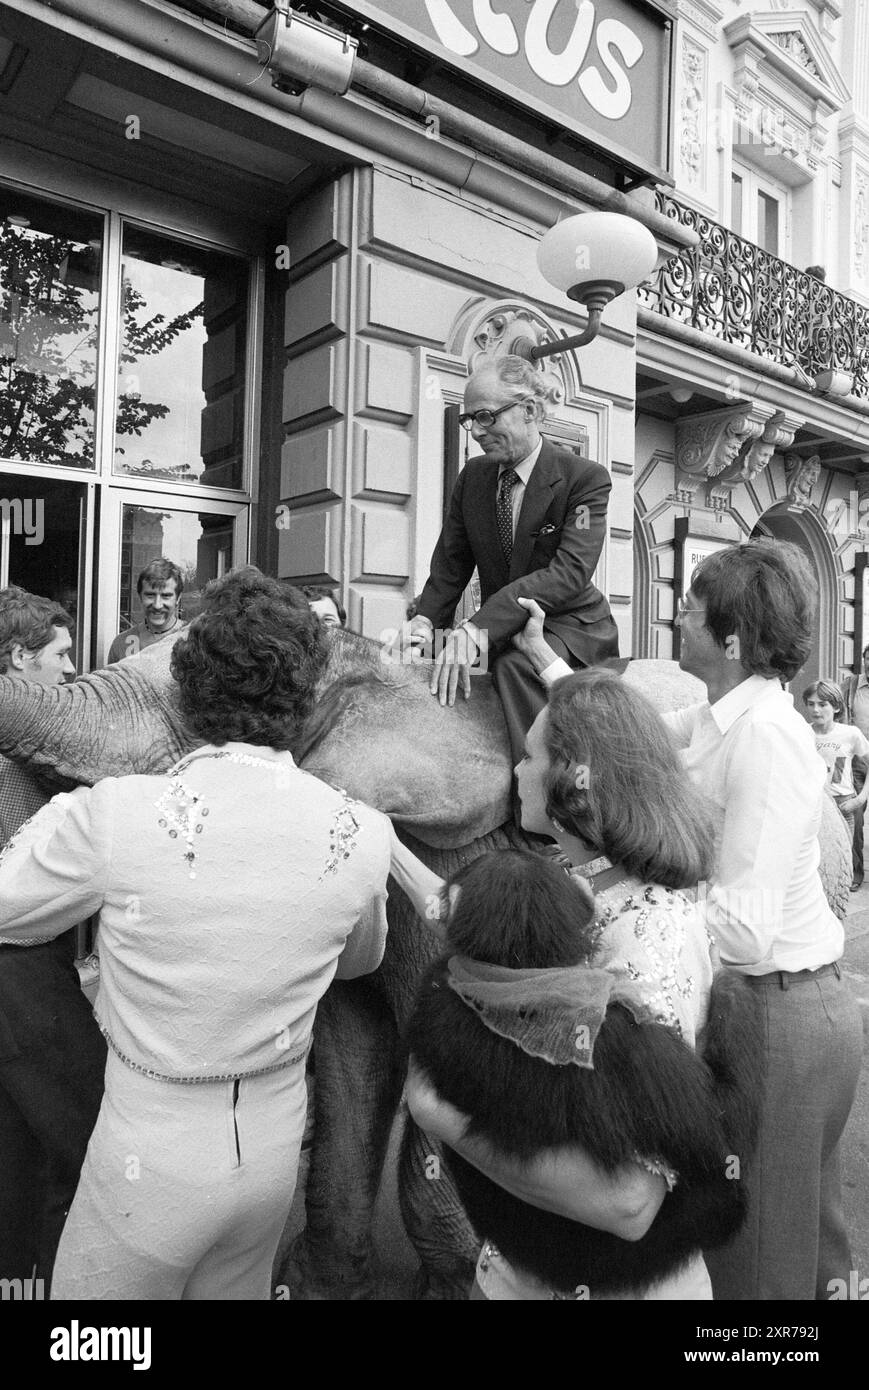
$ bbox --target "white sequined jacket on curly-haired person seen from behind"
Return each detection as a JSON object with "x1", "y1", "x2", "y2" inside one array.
[{"x1": 0, "y1": 744, "x2": 389, "y2": 1081}]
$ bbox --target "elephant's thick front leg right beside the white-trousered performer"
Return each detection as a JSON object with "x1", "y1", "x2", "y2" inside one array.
[{"x1": 282, "y1": 979, "x2": 405, "y2": 1300}]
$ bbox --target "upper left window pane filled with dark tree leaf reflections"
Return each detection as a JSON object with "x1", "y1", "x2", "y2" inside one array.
[{"x1": 0, "y1": 189, "x2": 103, "y2": 468}]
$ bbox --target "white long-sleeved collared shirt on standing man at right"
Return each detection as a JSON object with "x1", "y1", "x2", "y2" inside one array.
[{"x1": 539, "y1": 659, "x2": 844, "y2": 974}]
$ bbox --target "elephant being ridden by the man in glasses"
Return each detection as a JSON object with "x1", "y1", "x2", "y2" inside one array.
[{"x1": 0, "y1": 628, "x2": 851, "y2": 1300}]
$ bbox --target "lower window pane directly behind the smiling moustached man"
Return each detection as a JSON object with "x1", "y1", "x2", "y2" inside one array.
[{"x1": 118, "y1": 503, "x2": 234, "y2": 632}]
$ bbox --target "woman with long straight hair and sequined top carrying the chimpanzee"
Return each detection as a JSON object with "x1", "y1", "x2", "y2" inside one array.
[{"x1": 392, "y1": 656, "x2": 713, "y2": 1298}]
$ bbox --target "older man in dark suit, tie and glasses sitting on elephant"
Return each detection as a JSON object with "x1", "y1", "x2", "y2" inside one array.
[{"x1": 403, "y1": 356, "x2": 619, "y2": 763}]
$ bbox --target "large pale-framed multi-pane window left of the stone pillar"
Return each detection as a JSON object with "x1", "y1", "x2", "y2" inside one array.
[{"x1": 0, "y1": 186, "x2": 263, "y2": 669}]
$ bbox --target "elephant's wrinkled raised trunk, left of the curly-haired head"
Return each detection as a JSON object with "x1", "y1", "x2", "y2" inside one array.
[{"x1": 0, "y1": 634, "x2": 191, "y2": 785}]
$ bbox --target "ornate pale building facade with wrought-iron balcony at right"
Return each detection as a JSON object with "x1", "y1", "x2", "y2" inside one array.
[{"x1": 634, "y1": 0, "x2": 869, "y2": 687}]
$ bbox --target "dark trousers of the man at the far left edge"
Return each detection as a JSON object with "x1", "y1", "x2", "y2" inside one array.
[{"x1": 0, "y1": 931, "x2": 106, "y2": 1291}]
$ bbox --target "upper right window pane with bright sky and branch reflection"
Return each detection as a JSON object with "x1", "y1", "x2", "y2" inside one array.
[{"x1": 115, "y1": 227, "x2": 247, "y2": 488}]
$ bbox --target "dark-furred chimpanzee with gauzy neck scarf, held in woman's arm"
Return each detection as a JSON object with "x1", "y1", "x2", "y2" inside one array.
[{"x1": 407, "y1": 851, "x2": 762, "y2": 1298}]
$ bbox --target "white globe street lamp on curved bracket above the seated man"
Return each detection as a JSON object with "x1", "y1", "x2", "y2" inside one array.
[{"x1": 527, "y1": 213, "x2": 658, "y2": 361}]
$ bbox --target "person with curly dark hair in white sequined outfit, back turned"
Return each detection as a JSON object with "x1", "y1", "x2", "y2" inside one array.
[{"x1": 0, "y1": 567, "x2": 391, "y2": 1300}]
